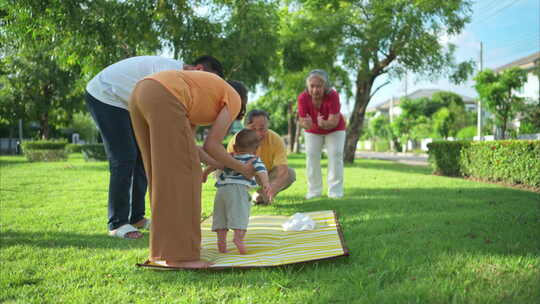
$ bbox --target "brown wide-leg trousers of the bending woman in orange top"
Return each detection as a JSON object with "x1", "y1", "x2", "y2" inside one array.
[{"x1": 129, "y1": 79, "x2": 202, "y2": 261}]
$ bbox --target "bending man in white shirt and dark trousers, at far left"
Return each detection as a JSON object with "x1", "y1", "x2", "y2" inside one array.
[{"x1": 86, "y1": 56, "x2": 223, "y2": 239}]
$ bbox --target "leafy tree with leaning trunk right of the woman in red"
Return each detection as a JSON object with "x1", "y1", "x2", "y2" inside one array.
[{"x1": 284, "y1": 0, "x2": 472, "y2": 162}]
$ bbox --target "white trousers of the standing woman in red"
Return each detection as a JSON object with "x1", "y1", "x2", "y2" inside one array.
[{"x1": 304, "y1": 131, "x2": 345, "y2": 197}]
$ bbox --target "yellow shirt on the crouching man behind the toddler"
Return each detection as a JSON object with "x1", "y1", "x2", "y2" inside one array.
[{"x1": 227, "y1": 130, "x2": 287, "y2": 171}]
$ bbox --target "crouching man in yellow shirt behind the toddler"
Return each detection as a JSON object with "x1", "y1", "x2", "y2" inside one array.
[{"x1": 227, "y1": 110, "x2": 296, "y2": 204}]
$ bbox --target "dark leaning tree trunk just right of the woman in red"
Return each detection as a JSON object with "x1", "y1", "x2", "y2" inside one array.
[{"x1": 343, "y1": 75, "x2": 374, "y2": 164}]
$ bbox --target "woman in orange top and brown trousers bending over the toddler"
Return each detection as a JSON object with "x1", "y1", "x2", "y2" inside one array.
[{"x1": 129, "y1": 70, "x2": 254, "y2": 268}]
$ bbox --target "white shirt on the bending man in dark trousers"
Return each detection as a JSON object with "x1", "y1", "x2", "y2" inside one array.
[{"x1": 86, "y1": 56, "x2": 183, "y2": 110}]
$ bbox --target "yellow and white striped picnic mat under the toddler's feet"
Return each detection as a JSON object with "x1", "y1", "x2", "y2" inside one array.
[{"x1": 201, "y1": 210, "x2": 348, "y2": 268}]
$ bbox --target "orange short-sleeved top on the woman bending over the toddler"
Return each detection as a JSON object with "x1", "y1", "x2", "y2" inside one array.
[{"x1": 145, "y1": 70, "x2": 242, "y2": 126}]
